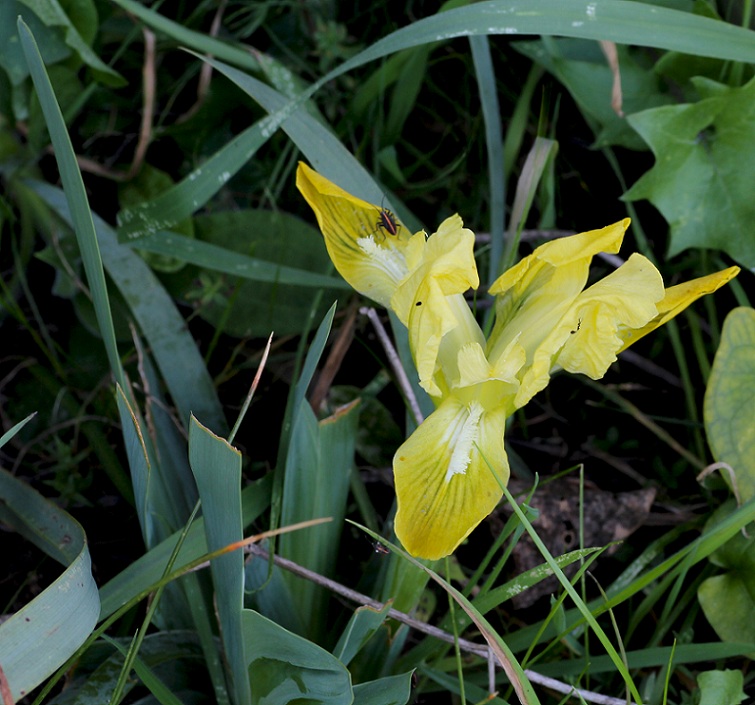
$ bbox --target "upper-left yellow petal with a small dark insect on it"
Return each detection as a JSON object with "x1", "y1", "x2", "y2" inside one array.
[{"x1": 296, "y1": 163, "x2": 414, "y2": 306}]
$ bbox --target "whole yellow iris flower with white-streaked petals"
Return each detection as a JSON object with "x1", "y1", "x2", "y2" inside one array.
[{"x1": 296, "y1": 164, "x2": 739, "y2": 559}]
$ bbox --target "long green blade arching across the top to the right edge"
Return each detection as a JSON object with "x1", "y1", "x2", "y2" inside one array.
[{"x1": 119, "y1": 0, "x2": 755, "y2": 239}]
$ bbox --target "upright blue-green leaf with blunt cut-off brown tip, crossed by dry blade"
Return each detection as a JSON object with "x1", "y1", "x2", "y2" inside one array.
[{"x1": 189, "y1": 416, "x2": 251, "y2": 705}]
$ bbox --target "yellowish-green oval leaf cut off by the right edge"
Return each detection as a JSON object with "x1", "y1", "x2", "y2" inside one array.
[{"x1": 704, "y1": 306, "x2": 755, "y2": 502}]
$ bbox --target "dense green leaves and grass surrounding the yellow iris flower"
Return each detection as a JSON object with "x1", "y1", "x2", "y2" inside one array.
[{"x1": 0, "y1": 0, "x2": 755, "y2": 705}]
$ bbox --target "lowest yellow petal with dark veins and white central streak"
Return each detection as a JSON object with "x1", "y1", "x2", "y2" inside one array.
[{"x1": 393, "y1": 396, "x2": 509, "y2": 559}]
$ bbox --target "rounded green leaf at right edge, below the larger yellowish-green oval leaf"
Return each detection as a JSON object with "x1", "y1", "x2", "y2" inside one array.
[{"x1": 697, "y1": 500, "x2": 755, "y2": 657}]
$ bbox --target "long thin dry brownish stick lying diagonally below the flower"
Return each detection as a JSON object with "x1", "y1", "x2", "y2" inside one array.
[{"x1": 244, "y1": 544, "x2": 626, "y2": 705}]
